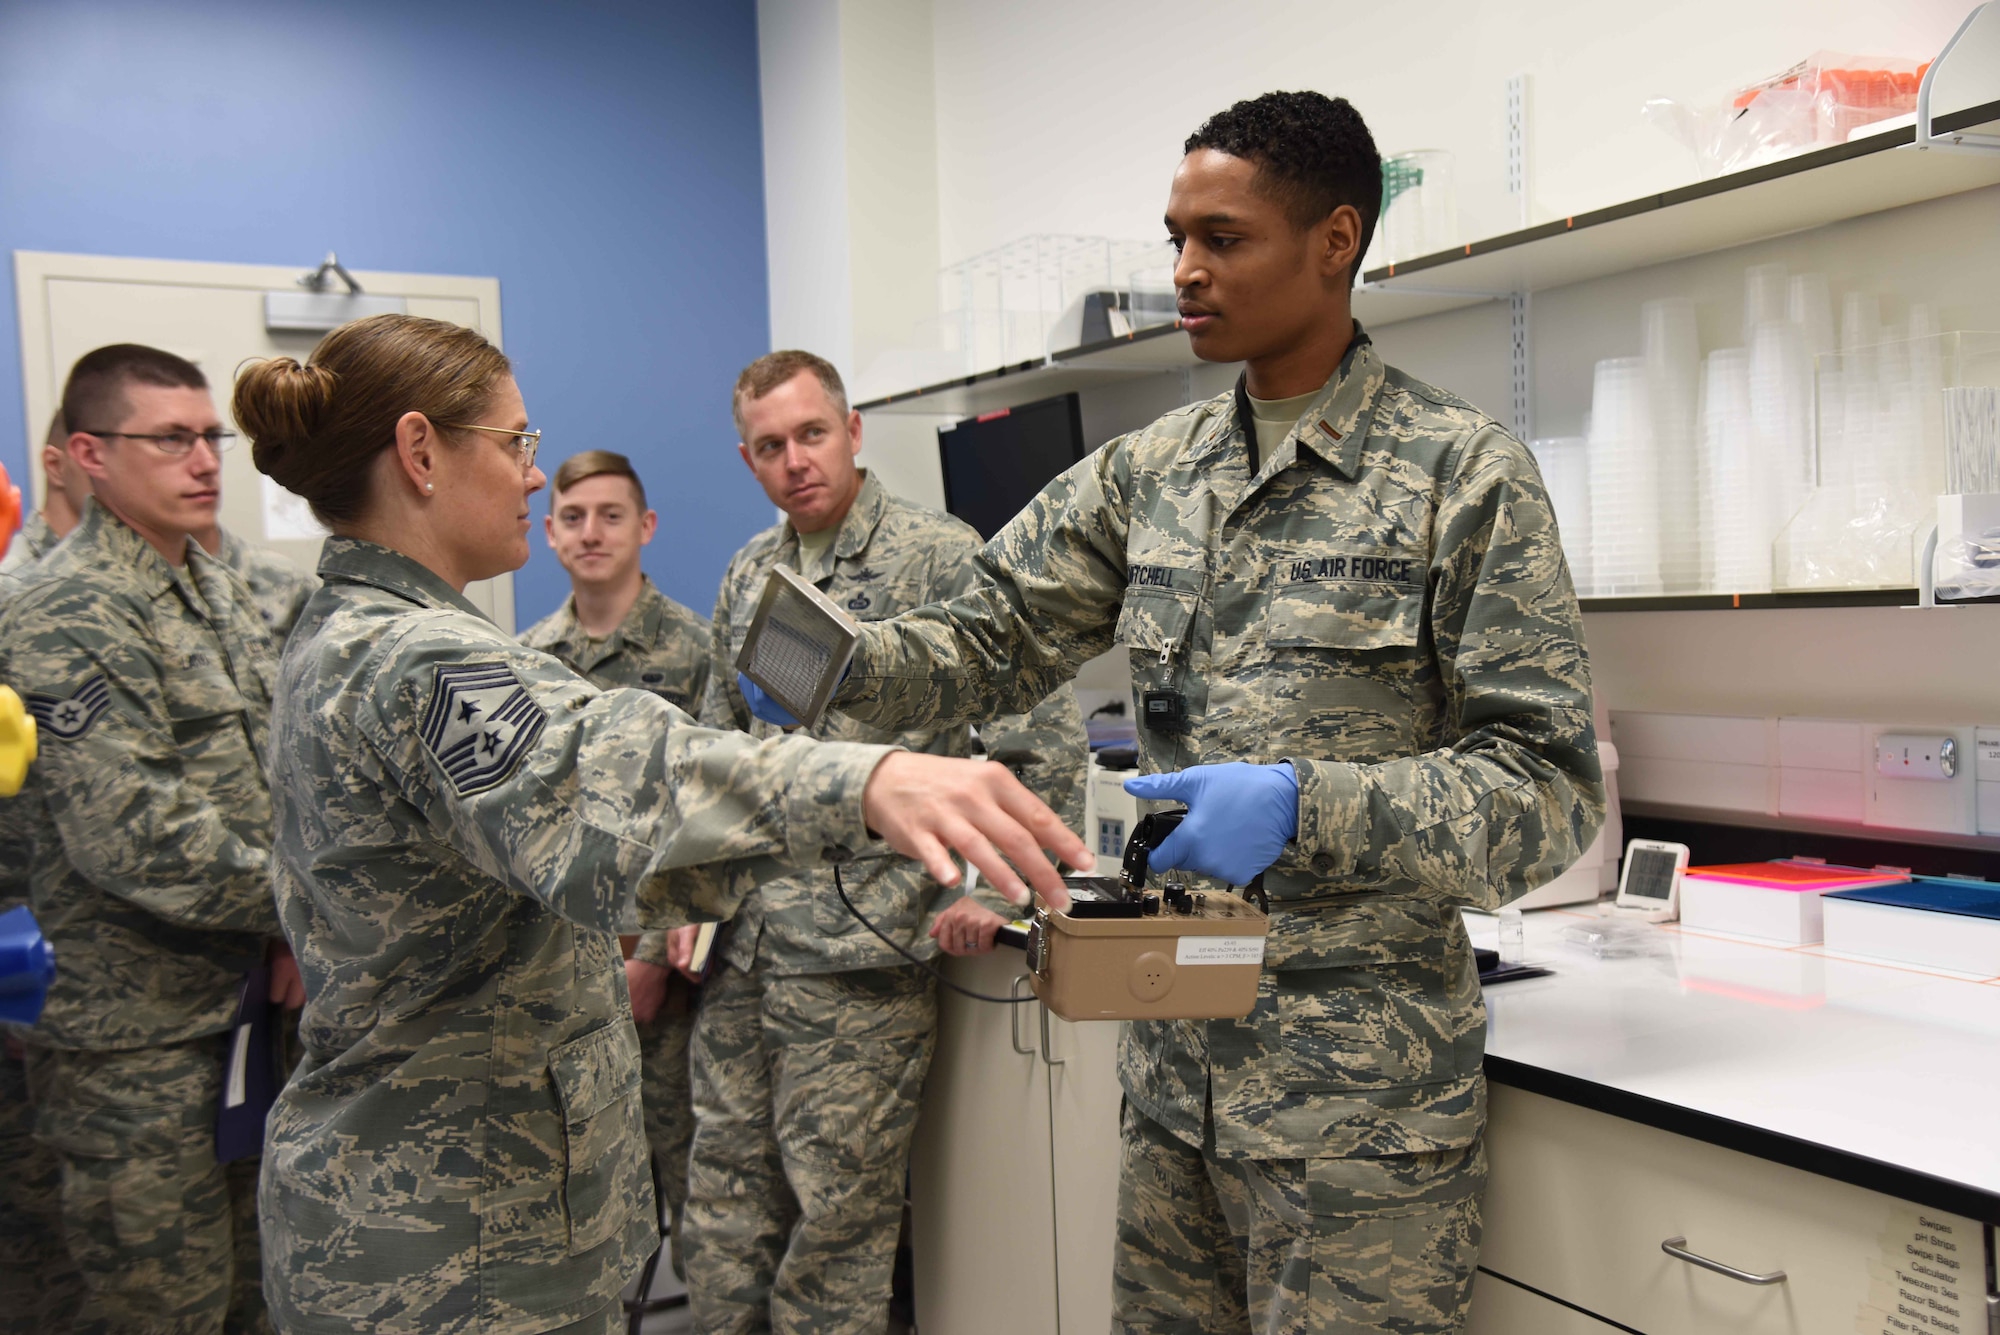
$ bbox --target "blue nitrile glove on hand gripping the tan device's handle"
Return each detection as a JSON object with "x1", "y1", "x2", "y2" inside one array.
[{"x1": 1126, "y1": 759, "x2": 1298, "y2": 885}]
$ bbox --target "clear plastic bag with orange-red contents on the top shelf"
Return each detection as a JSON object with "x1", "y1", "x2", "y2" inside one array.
[{"x1": 1642, "y1": 52, "x2": 1928, "y2": 178}]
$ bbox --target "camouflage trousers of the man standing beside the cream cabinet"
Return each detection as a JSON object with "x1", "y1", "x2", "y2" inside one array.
[{"x1": 684, "y1": 967, "x2": 938, "y2": 1335}]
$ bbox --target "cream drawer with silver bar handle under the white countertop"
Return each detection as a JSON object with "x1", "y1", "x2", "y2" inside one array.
[{"x1": 1480, "y1": 1085, "x2": 1984, "y2": 1335}]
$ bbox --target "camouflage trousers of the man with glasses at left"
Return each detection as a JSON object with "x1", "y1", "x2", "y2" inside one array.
[{"x1": 28, "y1": 1035, "x2": 272, "y2": 1335}]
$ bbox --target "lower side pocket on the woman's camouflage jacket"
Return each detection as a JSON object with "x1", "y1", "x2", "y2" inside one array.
[{"x1": 548, "y1": 1023, "x2": 652, "y2": 1255}]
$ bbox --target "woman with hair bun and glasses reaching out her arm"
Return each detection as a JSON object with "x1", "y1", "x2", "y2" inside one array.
[{"x1": 234, "y1": 316, "x2": 1088, "y2": 1333}]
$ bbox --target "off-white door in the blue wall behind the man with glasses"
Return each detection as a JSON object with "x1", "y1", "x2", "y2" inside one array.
[{"x1": 14, "y1": 250, "x2": 514, "y2": 634}]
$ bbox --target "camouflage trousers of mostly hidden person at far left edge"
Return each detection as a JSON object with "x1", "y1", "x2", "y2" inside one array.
[{"x1": 0, "y1": 1039, "x2": 84, "y2": 1335}]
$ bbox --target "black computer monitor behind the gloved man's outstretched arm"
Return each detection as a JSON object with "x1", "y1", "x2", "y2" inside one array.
[{"x1": 938, "y1": 394, "x2": 1088, "y2": 538}]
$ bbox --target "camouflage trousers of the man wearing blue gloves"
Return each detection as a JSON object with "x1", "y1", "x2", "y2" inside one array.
[{"x1": 1112, "y1": 1103, "x2": 1486, "y2": 1335}]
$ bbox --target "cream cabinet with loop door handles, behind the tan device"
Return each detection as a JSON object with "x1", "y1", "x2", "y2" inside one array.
[{"x1": 910, "y1": 947, "x2": 1120, "y2": 1335}]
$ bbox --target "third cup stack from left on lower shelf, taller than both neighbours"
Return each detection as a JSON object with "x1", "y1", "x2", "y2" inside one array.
[{"x1": 1640, "y1": 298, "x2": 1708, "y2": 594}]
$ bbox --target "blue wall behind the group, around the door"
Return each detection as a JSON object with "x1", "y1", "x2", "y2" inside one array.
[{"x1": 0, "y1": 0, "x2": 770, "y2": 626}]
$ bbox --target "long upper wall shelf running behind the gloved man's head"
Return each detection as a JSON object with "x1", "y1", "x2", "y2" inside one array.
[{"x1": 860, "y1": 102, "x2": 2000, "y2": 417}]
